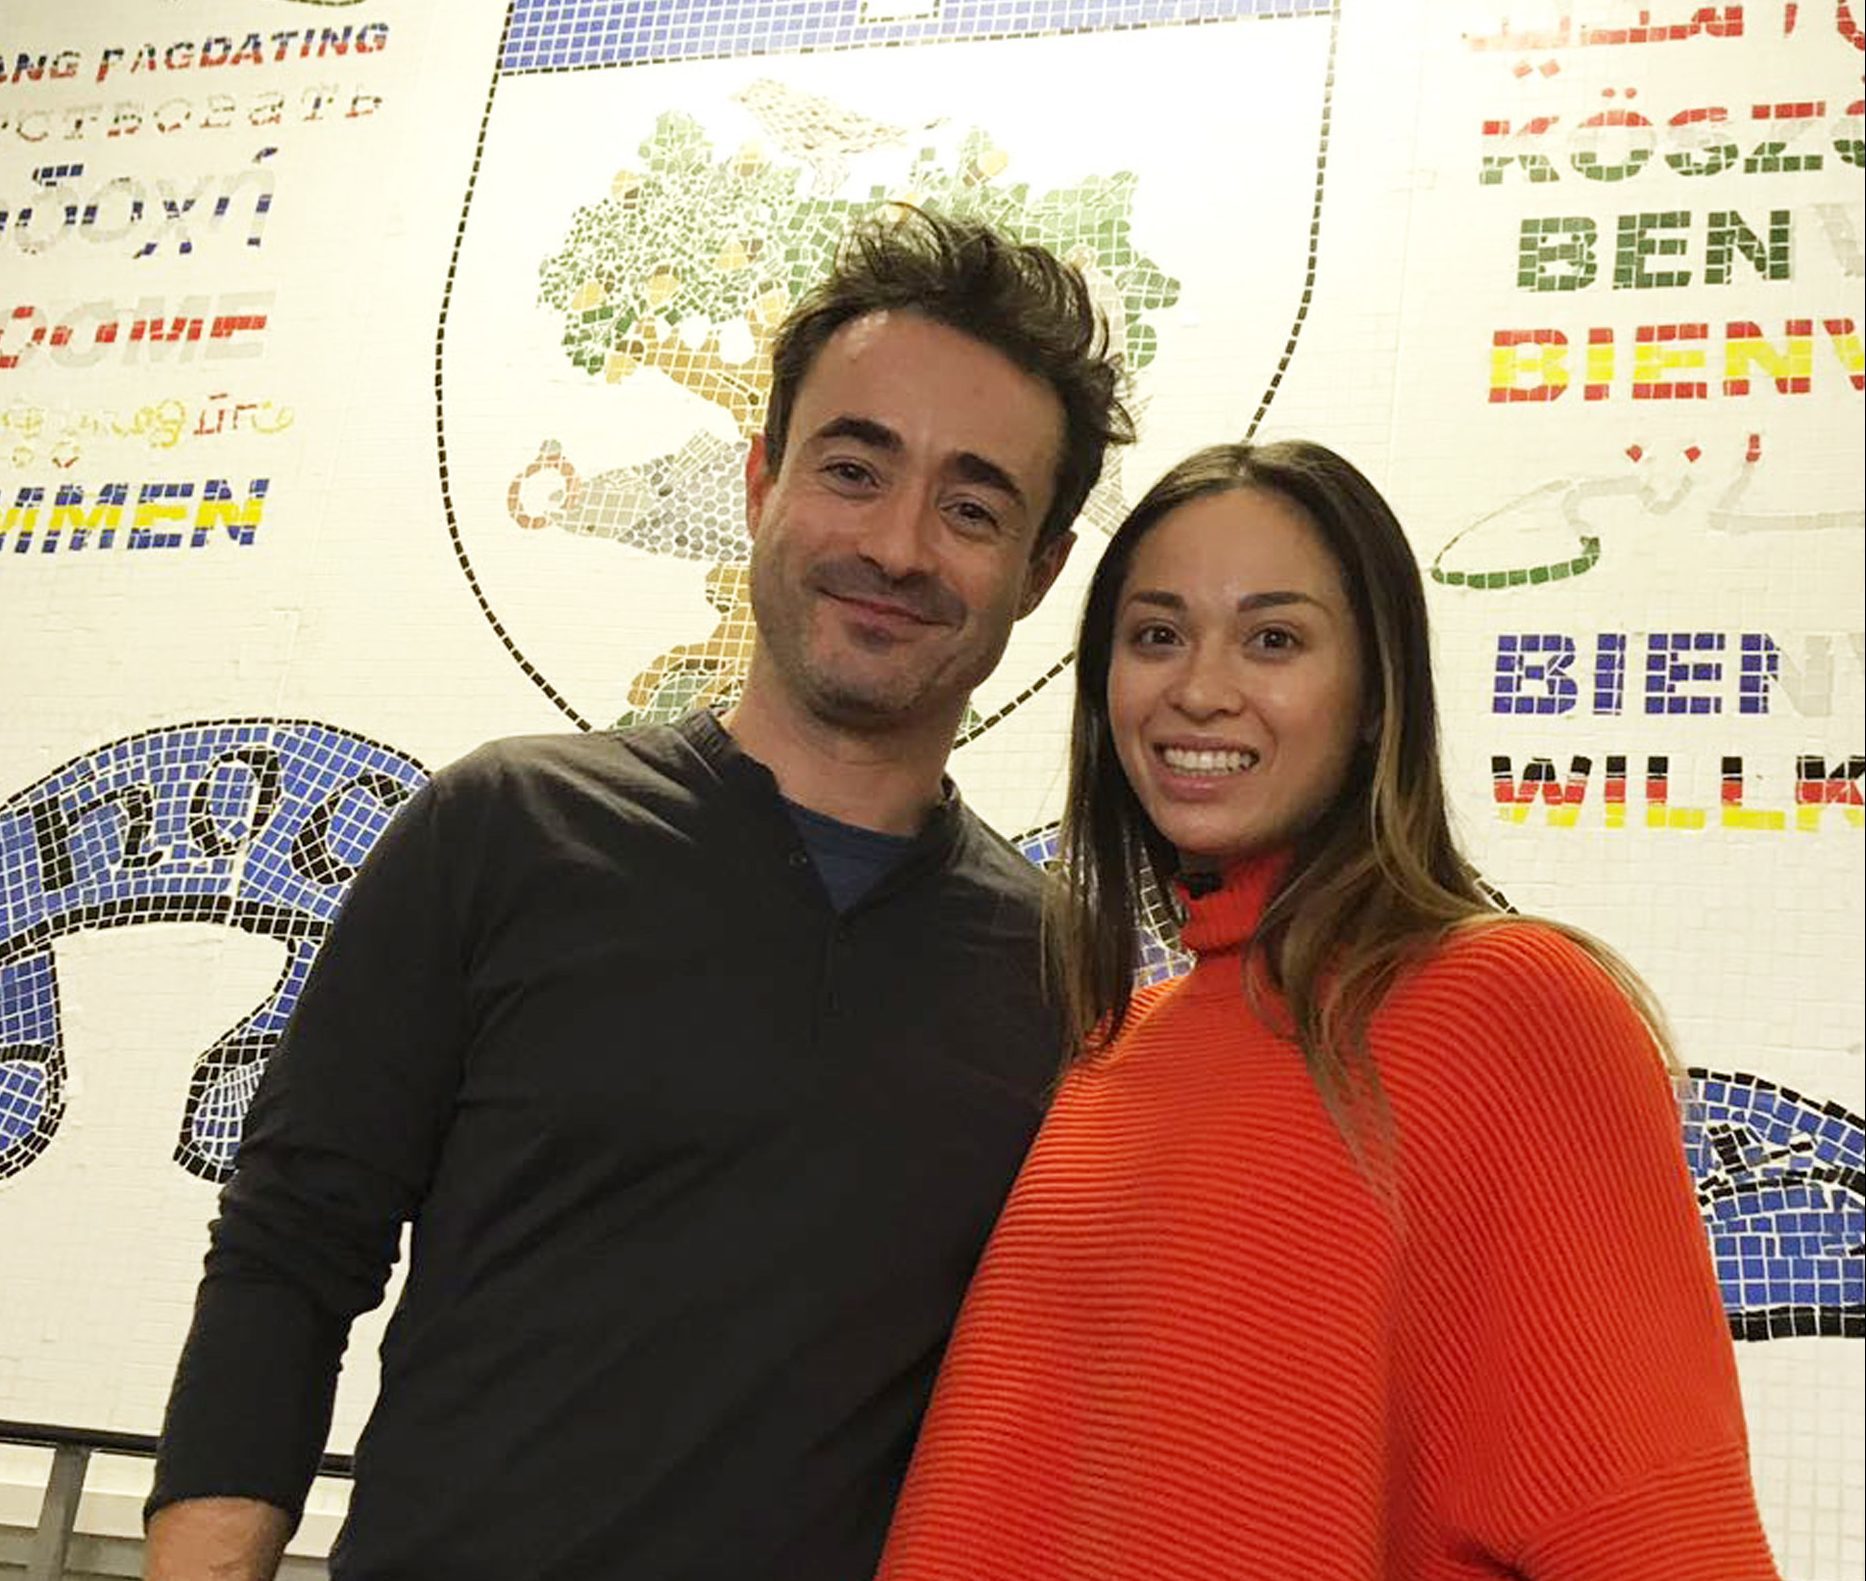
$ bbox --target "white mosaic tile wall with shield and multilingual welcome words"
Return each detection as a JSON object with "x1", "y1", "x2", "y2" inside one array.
[{"x1": 0, "y1": 0, "x2": 1866, "y2": 1581}]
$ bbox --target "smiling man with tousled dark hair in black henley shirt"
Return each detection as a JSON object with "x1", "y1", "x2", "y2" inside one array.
[{"x1": 146, "y1": 211, "x2": 1131, "y2": 1581}]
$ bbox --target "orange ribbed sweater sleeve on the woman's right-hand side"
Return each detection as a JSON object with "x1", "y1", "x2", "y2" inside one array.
[{"x1": 1381, "y1": 926, "x2": 1776, "y2": 1581}]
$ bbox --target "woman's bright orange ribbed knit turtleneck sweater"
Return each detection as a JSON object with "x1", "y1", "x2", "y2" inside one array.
[{"x1": 881, "y1": 862, "x2": 1776, "y2": 1581}]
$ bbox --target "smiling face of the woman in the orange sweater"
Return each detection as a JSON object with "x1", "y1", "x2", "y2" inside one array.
[{"x1": 1108, "y1": 487, "x2": 1364, "y2": 868}]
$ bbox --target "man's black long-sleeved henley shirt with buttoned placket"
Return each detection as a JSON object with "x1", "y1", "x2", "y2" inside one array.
[{"x1": 149, "y1": 715, "x2": 1058, "y2": 1581}]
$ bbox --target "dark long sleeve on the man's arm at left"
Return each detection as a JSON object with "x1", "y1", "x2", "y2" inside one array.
[{"x1": 147, "y1": 782, "x2": 467, "y2": 1518}]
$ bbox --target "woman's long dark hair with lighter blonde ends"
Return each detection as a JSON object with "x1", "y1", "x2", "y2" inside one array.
[{"x1": 1047, "y1": 441, "x2": 1678, "y2": 1159}]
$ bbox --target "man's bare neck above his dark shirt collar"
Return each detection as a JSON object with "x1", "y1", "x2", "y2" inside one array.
[{"x1": 720, "y1": 672, "x2": 957, "y2": 834}]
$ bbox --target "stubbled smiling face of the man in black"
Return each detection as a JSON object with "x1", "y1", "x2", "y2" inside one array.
[{"x1": 745, "y1": 312, "x2": 1073, "y2": 730}]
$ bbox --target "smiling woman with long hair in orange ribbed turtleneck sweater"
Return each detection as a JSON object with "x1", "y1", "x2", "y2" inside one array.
[{"x1": 881, "y1": 444, "x2": 1776, "y2": 1581}]
